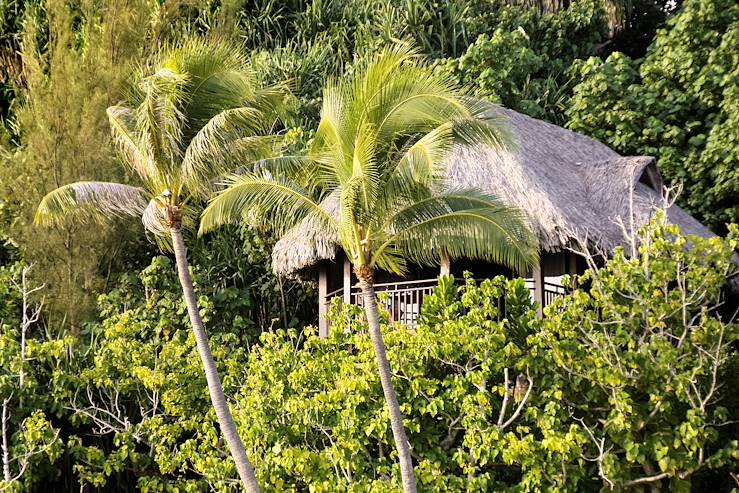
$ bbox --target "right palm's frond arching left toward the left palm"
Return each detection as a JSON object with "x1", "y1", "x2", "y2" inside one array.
[{"x1": 199, "y1": 172, "x2": 336, "y2": 234}]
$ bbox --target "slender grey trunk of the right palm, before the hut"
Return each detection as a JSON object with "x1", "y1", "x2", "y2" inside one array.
[{"x1": 359, "y1": 279, "x2": 416, "y2": 493}]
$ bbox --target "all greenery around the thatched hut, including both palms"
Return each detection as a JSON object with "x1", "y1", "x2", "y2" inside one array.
[{"x1": 0, "y1": 0, "x2": 739, "y2": 492}]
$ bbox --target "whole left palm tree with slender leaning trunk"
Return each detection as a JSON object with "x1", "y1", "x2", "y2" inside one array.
[{"x1": 35, "y1": 41, "x2": 285, "y2": 493}]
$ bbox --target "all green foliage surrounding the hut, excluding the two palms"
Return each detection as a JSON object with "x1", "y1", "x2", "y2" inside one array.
[{"x1": 0, "y1": 0, "x2": 739, "y2": 492}]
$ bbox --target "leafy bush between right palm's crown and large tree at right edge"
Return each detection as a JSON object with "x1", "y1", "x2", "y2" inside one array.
[{"x1": 441, "y1": 0, "x2": 606, "y2": 123}]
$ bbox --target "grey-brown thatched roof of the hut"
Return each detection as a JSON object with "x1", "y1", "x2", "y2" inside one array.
[{"x1": 272, "y1": 108, "x2": 712, "y2": 275}]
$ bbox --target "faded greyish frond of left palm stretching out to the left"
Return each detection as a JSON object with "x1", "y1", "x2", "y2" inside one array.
[{"x1": 34, "y1": 181, "x2": 146, "y2": 225}]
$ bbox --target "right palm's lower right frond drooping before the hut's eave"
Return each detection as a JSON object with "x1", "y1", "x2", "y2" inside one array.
[{"x1": 373, "y1": 190, "x2": 538, "y2": 272}]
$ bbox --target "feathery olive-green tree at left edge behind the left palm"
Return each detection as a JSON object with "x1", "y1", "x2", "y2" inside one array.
[{"x1": 0, "y1": 1, "x2": 162, "y2": 329}]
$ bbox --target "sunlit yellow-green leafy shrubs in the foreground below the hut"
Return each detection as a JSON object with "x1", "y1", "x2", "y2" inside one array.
[{"x1": 0, "y1": 220, "x2": 739, "y2": 492}]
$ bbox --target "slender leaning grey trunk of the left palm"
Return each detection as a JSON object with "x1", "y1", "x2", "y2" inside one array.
[{"x1": 170, "y1": 228, "x2": 260, "y2": 493}]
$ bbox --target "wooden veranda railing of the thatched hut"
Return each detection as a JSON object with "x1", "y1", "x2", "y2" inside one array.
[{"x1": 326, "y1": 279, "x2": 566, "y2": 327}]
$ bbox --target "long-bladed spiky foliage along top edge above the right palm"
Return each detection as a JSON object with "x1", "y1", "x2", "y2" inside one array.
[{"x1": 234, "y1": 0, "x2": 505, "y2": 60}]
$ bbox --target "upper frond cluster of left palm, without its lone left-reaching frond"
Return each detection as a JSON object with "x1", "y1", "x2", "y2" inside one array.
[{"x1": 115, "y1": 39, "x2": 289, "y2": 204}]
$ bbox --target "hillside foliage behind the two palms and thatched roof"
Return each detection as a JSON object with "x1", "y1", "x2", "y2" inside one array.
[{"x1": 0, "y1": 0, "x2": 737, "y2": 329}]
